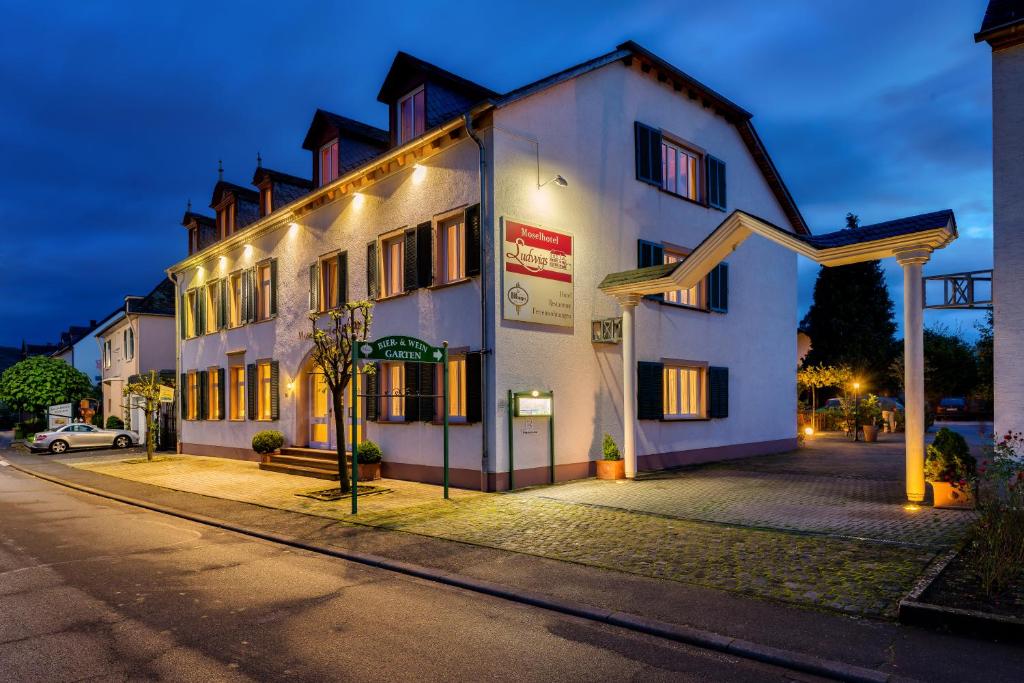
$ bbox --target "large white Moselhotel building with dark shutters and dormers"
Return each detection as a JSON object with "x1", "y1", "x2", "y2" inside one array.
[{"x1": 168, "y1": 42, "x2": 808, "y2": 490}]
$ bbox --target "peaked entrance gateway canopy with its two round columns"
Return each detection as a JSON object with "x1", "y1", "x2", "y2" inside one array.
[{"x1": 598, "y1": 210, "x2": 956, "y2": 503}]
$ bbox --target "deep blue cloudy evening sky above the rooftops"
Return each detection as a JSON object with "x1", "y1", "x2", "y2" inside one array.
[{"x1": 0, "y1": 0, "x2": 992, "y2": 345}]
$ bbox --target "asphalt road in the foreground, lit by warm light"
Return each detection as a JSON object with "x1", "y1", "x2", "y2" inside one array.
[{"x1": 0, "y1": 463, "x2": 811, "y2": 683}]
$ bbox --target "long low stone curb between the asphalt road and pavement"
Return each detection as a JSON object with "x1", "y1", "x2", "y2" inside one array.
[{"x1": 7, "y1": 461, "x2": 897, "y2": 683}]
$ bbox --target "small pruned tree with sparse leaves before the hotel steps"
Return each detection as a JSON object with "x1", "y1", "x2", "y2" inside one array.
[{"x1": 307, "y1": 300, "x2": 374, "y2": 494}]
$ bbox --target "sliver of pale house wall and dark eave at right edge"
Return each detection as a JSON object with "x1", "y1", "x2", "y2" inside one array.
[{"x1": 975, "y1": 0, "x2": 1024, "y2": 434}]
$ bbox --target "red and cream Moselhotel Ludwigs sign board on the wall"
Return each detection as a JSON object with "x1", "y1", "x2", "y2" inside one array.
[{"x1": 502, "y1": 217, "x2": 572, "y2": 328}]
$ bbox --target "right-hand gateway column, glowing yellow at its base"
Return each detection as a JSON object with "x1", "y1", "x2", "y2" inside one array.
[{"x1": 896, "y1": 249, "x2": 931, "y2": 503}]
